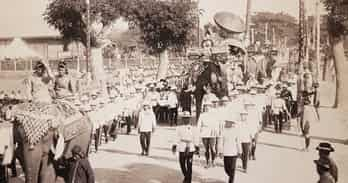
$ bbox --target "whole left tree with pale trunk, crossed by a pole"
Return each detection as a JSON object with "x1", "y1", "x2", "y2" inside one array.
[{"x1": 44, "y1": 0, "x2": 129, "y2": 93}]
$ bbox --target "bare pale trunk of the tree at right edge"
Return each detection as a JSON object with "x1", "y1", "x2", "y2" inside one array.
[{"x1": 332, "y1": 37, "x2": 348, "y2": 110}]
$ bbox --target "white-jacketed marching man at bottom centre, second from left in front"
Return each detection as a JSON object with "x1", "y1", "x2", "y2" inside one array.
[{"x1": 172, "y1": 111, "x2": 199, "y2": 183}]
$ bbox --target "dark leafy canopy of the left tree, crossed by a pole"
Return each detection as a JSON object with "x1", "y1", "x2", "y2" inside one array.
[{"x1": 44, "y1": 0, "x2": 128, "y2": 46}]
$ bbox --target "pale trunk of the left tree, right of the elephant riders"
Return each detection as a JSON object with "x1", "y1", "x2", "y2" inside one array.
[{"x1": 90, "y1": 48, "x2": 106, "y2": 94}]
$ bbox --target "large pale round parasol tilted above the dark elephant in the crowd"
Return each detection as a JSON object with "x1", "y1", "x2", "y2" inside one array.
[{"x1": 214, "y1": 12, "x2": 245, "y2": 33}]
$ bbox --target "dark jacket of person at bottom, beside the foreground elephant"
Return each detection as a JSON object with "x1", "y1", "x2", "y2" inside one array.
[{"x1": 68, "y1": 158, "x2": 95, "y2": 183}]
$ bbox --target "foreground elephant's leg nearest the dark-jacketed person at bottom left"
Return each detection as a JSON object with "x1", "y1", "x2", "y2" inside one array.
[{"x1": 40, "y1": 154, "x2": 56, "y2": 183}]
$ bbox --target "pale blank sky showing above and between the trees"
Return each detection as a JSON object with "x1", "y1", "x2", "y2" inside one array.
[{"x1": 0, "y1": 0, "x2": 326, "y2": 37}]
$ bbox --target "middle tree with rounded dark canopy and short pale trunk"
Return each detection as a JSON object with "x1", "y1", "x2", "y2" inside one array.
[{"x1": 124, "y1": 0, "x2": 197, "y2": 79}]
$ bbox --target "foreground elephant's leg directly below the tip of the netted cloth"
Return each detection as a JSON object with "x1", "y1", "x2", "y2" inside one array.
[{"x1": 23, "y1": 144, "x2": 42, "y2": 183}]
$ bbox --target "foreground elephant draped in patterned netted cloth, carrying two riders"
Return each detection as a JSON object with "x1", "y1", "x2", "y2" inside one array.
[{"x1": 14, "y1": 101, "x2": 92, "y2": 183}]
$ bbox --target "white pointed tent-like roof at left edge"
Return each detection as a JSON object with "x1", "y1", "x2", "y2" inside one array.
[{"x1": 0, "y1": 38, "x2": 43, "y2": 60}]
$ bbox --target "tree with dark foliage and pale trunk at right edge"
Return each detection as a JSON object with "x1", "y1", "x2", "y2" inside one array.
[{"x1": 322, "y1": 0, "x2": 348, "y2": 110}]
